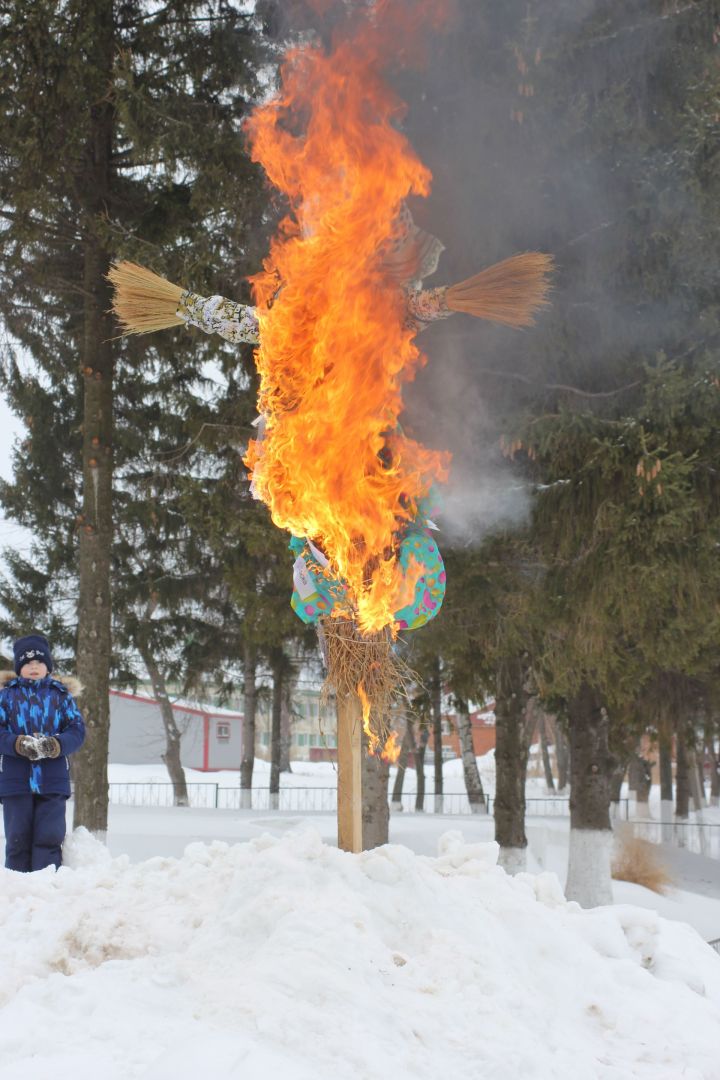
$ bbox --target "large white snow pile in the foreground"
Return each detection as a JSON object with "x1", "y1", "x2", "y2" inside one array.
[{"x1": 0, "y1": 826, "x2": 720, "y2": 1080}]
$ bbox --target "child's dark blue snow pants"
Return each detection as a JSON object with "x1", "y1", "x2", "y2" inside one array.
[{"x1": 2, "y1": 792, "x2": 67, "y2": 872}]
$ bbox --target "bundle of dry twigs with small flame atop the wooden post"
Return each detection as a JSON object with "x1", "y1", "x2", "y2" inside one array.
[{"x1": 323, "y1": 619, "x2": 411, "y2": 762}]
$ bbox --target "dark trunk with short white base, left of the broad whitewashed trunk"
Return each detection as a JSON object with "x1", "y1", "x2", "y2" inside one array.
[{"x1": 493, "y1": 657, "x2": 534, "y2": 874}]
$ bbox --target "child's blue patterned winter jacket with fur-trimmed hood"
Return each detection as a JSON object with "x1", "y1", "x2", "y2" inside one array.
[{"x1": 0, "y1": 672, "x2": 85, "y2": 799}]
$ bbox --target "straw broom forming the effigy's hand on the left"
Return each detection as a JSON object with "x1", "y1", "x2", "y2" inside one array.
[{"x1": 108, "y1": 260, "x2": 185, "y2": 335}]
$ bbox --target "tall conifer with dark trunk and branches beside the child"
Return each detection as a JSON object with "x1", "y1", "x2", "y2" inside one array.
[{"x1": 0, "y1": 0, "x2": 264, "y2": 832}]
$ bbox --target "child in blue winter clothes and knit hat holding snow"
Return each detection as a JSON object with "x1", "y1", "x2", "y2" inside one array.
[{"x1": 0, "y1": 634, "x2": 85, "y2": 872}]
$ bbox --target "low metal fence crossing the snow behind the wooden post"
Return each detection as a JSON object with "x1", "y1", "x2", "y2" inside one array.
[{"x1": 109, "y1": 782, "x2": 628, "y2": 820}]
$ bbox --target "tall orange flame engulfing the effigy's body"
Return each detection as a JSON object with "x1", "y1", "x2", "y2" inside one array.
[{"x1": 247, "y1": 5, "x2": 447, "y2": 632}]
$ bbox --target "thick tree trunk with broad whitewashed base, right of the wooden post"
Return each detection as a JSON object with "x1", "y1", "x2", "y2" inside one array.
[{"x1": 566, "y1": 684, "x2": 614, "y2": 907}]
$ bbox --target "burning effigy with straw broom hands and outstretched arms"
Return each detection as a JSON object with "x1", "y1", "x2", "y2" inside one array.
[{"x1": 109, "y1": 3, "x2": 552, "y2": 773}]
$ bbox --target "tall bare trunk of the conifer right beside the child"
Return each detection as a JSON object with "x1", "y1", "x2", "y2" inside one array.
[{"x1": 72, "y1": 0, "x2": 116, "y2": 837}]
